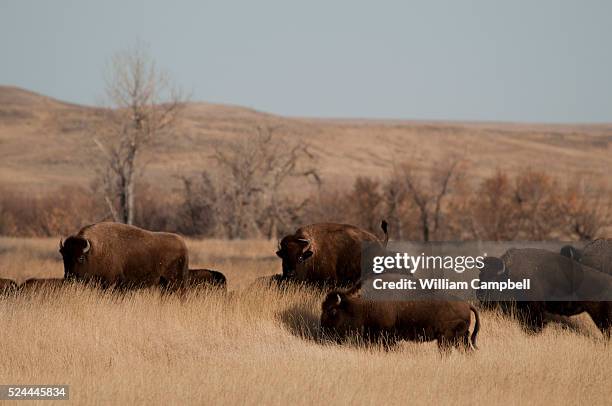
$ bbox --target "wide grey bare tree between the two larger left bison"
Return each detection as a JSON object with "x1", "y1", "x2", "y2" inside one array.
[{"x1": 214, "y1": 126, "x2": 320, "y2": 238}]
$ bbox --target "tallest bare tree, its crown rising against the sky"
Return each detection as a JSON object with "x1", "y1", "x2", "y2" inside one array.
[{"x1": 94, "y1": 45, "x2": 183, "y2": 224}]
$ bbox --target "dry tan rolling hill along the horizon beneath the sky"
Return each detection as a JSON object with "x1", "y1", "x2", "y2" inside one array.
[{"x1": 0, "y1": 86, "x2": 612, "y2": 192}]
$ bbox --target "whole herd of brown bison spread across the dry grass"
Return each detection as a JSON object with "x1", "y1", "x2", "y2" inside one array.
[{"x1": 0, "y1": 221, "x2": 612, "y2": 350}]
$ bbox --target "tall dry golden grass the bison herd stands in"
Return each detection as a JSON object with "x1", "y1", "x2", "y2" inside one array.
[{"x1": 0, "y1": 238, "x2": 612, "y2": 404}]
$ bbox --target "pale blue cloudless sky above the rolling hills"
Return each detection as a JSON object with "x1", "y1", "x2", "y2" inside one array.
[{"x1": 0, "y1": 0, "x2": 612, "y2": 122}]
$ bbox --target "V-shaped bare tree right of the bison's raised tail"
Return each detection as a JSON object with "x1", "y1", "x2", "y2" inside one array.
[{"x1": 399, "y1": 157, "x2": 460, "y2": 241}]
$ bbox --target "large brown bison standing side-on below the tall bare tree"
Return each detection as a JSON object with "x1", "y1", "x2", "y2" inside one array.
[{"x1": 60, "y1": 223, "x2": 189, "y2": 288}]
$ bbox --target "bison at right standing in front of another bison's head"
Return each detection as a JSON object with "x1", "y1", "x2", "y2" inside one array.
[{"x1": 479, "y1": 247, "x2": 612, "y2": 338}]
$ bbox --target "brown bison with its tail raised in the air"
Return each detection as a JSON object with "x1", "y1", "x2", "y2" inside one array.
[{"x1": 276, "y1": 221, "x2": 389, "y2": 285}]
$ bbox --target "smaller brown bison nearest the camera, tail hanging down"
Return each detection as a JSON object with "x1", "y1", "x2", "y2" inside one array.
[{"x1": 321, "y1": 290, "x2": 480, "y2": 349}]
